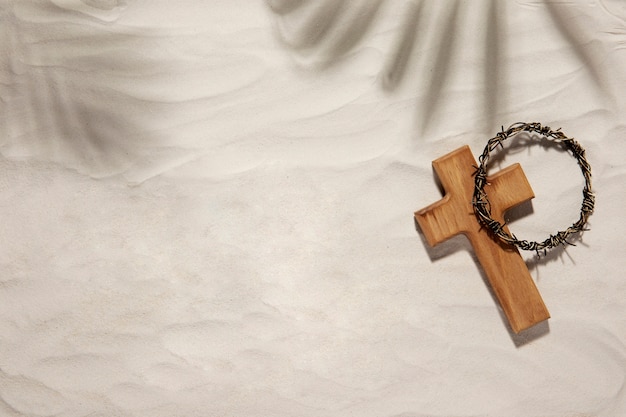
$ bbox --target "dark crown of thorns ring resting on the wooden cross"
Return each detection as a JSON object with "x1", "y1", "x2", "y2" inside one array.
[{"x1": 472, "y1": 122, "x2": 595, "y2": 254}]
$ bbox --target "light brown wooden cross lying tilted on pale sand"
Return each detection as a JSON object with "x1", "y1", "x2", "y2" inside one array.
[{"x1": 415, "y1": 146, "x2": 550, "y2": 333}]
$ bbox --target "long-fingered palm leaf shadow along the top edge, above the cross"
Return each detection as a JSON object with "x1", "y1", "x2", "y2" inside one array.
[{"x1": 267, "y1": 0, "x2": 606, "y2": 134}]
